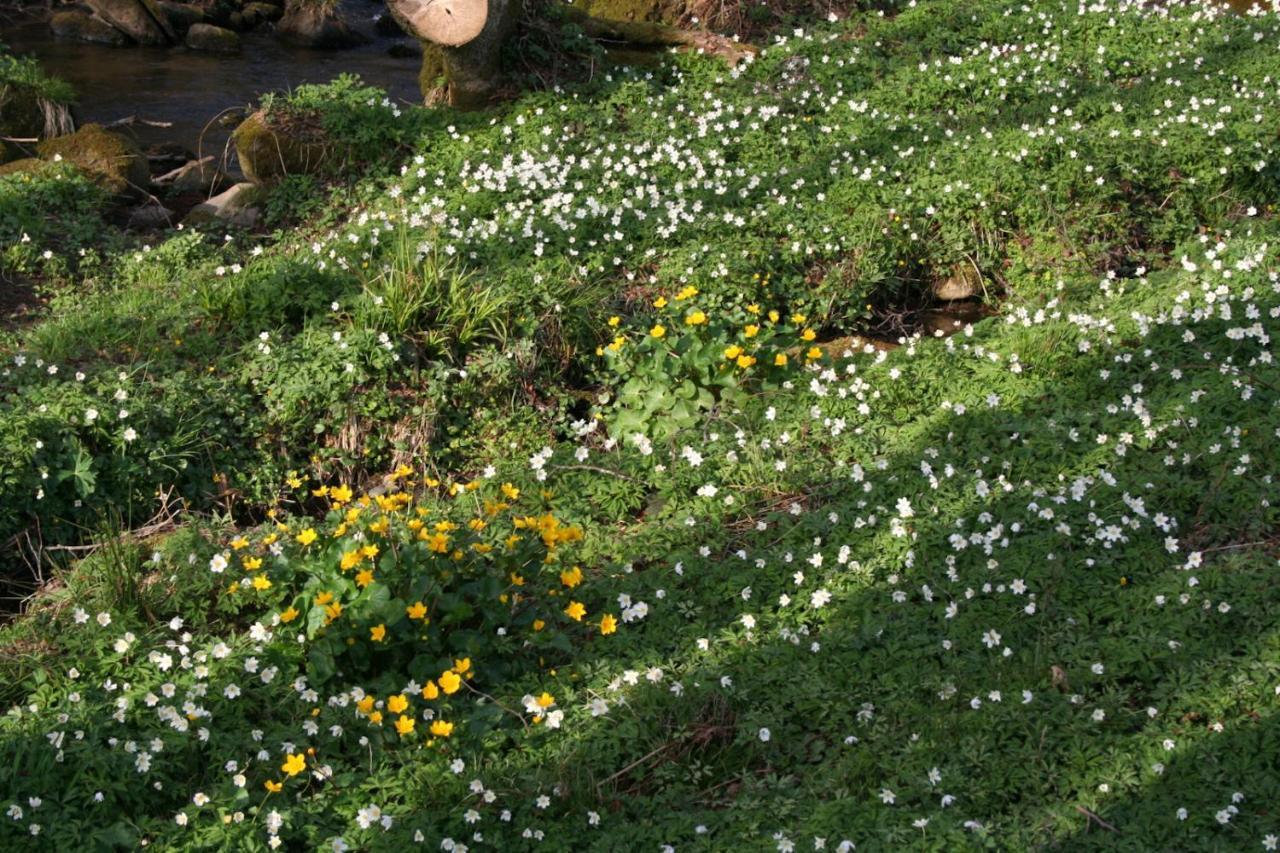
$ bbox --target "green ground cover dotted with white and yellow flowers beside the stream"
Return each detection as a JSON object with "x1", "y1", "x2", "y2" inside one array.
[{"x1": 0, "y1": 0, "x2": 1280, "y2": 850}]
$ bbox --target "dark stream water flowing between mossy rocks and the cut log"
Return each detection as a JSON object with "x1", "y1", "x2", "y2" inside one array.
[{"x1": 0, "y1": 3, "x2": 421, "y2": 165}]
